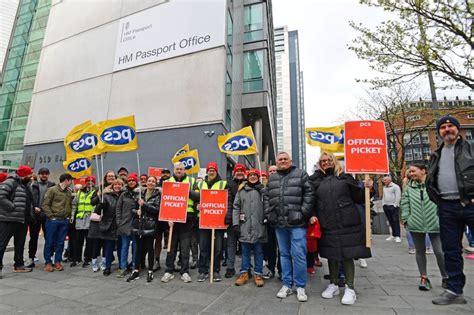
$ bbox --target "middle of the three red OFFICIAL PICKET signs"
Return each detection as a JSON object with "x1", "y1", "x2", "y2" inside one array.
[{"x1": 199, "y1": 189, "x2": 228, "y2": 229}]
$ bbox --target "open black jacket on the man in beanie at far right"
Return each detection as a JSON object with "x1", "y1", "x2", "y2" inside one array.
[{"x1": 426, "y1": 137, "x2": 474, "y2": 205}]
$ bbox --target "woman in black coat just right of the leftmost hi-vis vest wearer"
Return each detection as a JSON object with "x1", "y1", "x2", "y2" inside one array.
[{"x1": 94, "y1": 179, "x2": 123, "y2": 276}]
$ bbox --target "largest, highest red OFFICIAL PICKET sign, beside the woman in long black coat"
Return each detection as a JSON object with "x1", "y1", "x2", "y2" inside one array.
[{"x1": 344, "y1": 120, "x2": 389, "y2": 174}]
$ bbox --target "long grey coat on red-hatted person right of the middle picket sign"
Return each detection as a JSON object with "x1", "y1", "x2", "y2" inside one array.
[{"x1": 232, "y1": 183, "x2": 268, "y2": 244}]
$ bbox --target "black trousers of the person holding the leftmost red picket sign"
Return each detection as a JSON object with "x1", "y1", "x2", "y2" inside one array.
[{"x1": 165, "y1": 218, "x2": 193, "y2": 274}]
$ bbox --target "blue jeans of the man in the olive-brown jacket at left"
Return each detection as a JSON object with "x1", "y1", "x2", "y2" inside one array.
[{"x1": 43, "y1": 219, "x2": 69, "y2": 264}]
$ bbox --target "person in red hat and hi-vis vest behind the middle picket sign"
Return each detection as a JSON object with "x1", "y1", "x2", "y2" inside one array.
[{"x1": 197, "y1": 162, "x2": 229, "y2": 282}]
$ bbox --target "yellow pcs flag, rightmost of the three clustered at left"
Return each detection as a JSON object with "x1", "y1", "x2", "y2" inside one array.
[{"x1": 97, "y1": 116, "x2": 138, "y2": 152}]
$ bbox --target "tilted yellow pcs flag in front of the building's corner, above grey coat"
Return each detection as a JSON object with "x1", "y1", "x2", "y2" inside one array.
[{"x1": 217, "y1": 126, "x2": 257, "y2": 155}]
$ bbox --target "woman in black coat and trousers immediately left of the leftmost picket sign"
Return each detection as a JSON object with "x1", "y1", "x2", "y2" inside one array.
[{"x1": 127, "y1": 176, "x2": 161, "y2": 282}]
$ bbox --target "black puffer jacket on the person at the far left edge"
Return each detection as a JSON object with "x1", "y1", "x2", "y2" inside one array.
[{"x1": 0, "y1": 175, "x2": 35, "y2": 223}]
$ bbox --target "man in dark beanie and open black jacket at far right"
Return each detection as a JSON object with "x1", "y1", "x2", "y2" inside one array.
[{"x1": 426, "y1": 116, "x2": 474, "y2": 305}]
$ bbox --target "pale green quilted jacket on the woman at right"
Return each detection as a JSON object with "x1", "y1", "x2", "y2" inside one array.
[{"x1": 400, "y1": 181, "x2": 439, "y2": 233}]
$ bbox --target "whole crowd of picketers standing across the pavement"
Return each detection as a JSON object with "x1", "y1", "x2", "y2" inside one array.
[{"x1": 0, "y1": 116, "x2": 474, "y2": 305}]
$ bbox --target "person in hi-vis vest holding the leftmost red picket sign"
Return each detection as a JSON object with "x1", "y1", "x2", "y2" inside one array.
[{"x1": 161, "y1": 162, "x2": 199, "y2": 283}]
